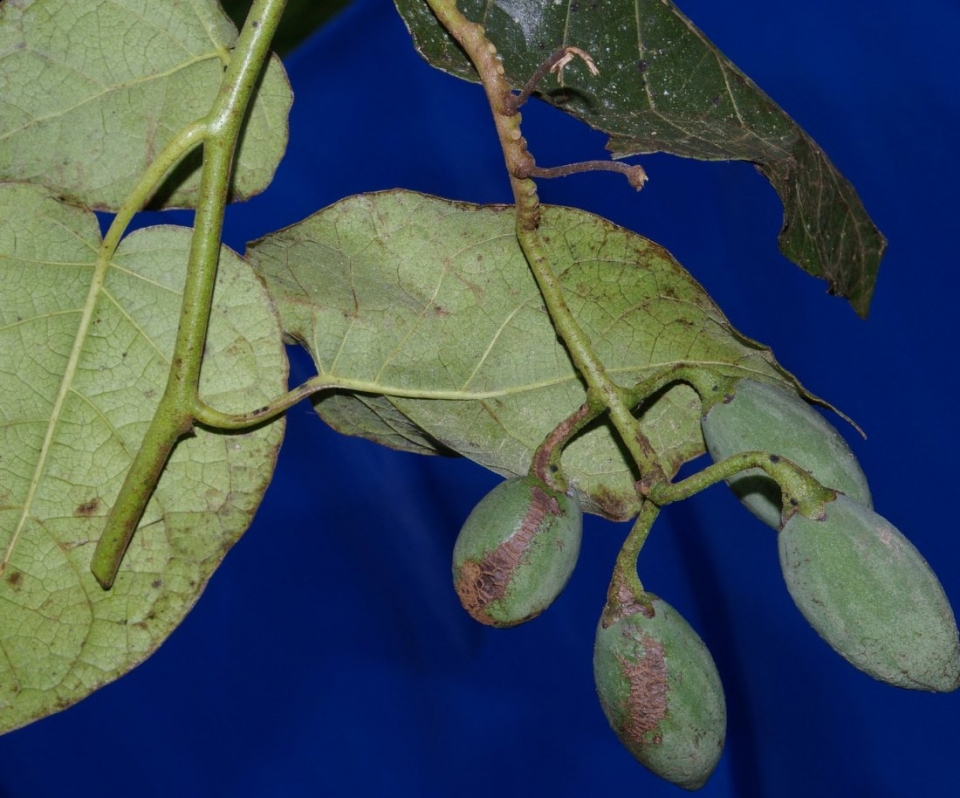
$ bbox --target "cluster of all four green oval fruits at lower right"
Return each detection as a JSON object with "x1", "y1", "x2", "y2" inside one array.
[{"x1": 453, "y1": 379, "x2": 960, "y2": 789}]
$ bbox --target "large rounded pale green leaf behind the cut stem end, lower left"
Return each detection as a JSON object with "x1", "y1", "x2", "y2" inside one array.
[{"x1": 0, "y1": 185, "x2": 287, "y2": 731}]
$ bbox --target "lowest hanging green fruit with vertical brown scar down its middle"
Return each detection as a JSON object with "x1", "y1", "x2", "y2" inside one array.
[{"x1": 593, "y1": 596, "x2": 727, "y2": 790}]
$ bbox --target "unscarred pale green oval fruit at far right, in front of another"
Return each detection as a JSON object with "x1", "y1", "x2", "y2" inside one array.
[{"x1": 779, "y1": 494, "x2": 960, "y2": 692}]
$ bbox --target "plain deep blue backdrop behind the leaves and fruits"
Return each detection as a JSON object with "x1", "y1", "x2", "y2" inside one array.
[{"x1": 0, "y1": 0, "x2": 960, "y2": 798}]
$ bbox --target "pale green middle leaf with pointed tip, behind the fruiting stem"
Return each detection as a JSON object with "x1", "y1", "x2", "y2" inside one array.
[{"x1": 248, "y1": 191, "x2": 795, "y2": 519}]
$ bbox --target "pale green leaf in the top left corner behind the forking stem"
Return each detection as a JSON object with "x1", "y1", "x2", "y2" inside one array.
[{"x1": 0, "y1": 0, "x2": 292, "y2": 211}]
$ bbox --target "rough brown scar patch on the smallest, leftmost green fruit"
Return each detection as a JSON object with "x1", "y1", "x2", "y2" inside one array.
[{"x1": 454, "y1": 487, "x2": 561, "y2": 626}]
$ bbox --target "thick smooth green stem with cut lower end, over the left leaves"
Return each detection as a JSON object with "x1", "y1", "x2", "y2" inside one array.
[{"x1": 90, "y1": 0, "x2": 286, "y2": 590}]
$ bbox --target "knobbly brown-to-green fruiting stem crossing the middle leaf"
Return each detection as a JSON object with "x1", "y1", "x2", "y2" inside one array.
[{"x1": 427, "y1": 0, "x2": 665, "y2": 488}]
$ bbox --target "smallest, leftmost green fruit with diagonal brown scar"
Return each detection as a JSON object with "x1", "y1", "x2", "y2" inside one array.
[{"x1": 453, "y1": 476, "x2": 583, "y2": 626}]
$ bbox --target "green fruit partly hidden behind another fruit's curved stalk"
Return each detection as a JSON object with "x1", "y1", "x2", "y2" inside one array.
[{"x1": 701, "y1": 380, "x2": 872, "y2": 529}]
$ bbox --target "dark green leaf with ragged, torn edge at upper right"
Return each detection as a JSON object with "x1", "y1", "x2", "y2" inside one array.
[{"x1": 395, "y1": 0, "x2": 886, "y2": 316}]
